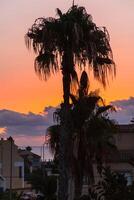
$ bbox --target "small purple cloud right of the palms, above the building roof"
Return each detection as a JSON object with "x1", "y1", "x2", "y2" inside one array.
[{"x1": 110, "y1": 97, "x2": 134, "y2": 124}]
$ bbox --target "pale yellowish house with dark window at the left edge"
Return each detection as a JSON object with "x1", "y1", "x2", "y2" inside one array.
[{"x1": 0, "y1": 137, "x2": 24, "y2": 191}]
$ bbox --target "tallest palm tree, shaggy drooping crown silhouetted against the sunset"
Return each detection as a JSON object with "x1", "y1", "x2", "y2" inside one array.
[{"x1": 26, "y1": 5, "x2": 115, "y2": 200}]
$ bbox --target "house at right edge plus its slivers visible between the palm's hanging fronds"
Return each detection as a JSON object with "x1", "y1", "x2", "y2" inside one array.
[{"x1": 69, "y1": 124, "x2": 134, "y2": 200}]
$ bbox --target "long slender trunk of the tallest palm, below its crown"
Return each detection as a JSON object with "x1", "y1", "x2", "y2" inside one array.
[{"x1": 58, "y1": 50, "x2": 73, "y2": 200}]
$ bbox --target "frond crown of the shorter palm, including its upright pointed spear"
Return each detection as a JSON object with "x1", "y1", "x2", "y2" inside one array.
[{"x1": 47, "y1": 71, "x2": 116, "y2": 169}]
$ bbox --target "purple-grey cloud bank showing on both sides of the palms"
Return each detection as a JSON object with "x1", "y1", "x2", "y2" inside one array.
[{"x1": 0, "y1": 97, "x2": 134, "y2": 140}]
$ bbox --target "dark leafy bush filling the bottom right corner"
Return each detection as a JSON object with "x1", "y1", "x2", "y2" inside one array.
[{"x1": 90, "y1": 168, "x2": 134, "y2": 200}]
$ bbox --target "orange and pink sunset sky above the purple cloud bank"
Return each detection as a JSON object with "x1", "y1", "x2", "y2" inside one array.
[{"x1": 0, "y1": 0, "x2": 134, "y2": 147}]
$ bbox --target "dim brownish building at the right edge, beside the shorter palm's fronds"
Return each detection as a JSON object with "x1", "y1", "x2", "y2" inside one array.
[{"x1": 109, "y1": 124, "x2": 134, "y2": 183}]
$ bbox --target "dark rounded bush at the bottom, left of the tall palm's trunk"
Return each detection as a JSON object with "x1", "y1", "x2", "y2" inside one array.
[{"x1": 29, "y1": 169, "x2": 57, "y2": 200}]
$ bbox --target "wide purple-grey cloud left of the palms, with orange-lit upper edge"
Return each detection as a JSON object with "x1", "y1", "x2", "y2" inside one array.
[{"x1": 0, "y1": 107, "x2": 56, "y2": 137}]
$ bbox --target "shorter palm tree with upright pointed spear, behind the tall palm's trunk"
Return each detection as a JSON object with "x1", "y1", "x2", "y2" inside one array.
[{"x1": 48, "y1": 71, "x2": 115, "y2": 199}]
